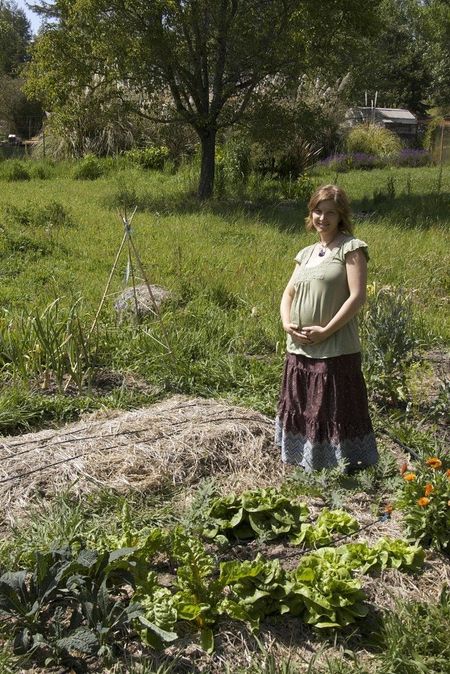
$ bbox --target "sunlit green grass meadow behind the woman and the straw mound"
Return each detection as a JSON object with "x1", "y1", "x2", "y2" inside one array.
[{"x1": 0, "y1": 160, "x2": 450, "y2": 429}]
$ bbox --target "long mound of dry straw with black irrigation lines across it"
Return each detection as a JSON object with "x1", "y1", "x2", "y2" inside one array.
[{"x1": 0, "y1": 396, "x2": 280, "y2": 521}]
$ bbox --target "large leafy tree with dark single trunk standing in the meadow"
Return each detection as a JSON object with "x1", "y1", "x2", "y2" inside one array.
[{"x1": 28, "y1": 0, "x2": 378, "y2": 198}]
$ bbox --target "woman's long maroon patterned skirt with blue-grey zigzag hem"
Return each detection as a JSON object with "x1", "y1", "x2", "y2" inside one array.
[{"x1": 275, "y1": 353, "x2": 378, "y2": 471}]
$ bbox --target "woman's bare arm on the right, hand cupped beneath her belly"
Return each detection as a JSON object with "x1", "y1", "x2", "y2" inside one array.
[{"x1": 303, "y1": 248, "x2": 367, "y2": 344}]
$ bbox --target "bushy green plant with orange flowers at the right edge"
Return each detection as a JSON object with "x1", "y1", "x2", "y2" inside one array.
[{"x1": 398, "y1": 456, "x2": 450, "y2": 554}]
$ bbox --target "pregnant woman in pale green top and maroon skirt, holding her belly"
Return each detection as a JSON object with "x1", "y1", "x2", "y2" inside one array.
[{"x1": 276, "y1": 185, "x2": 378, "y2": 471}]
